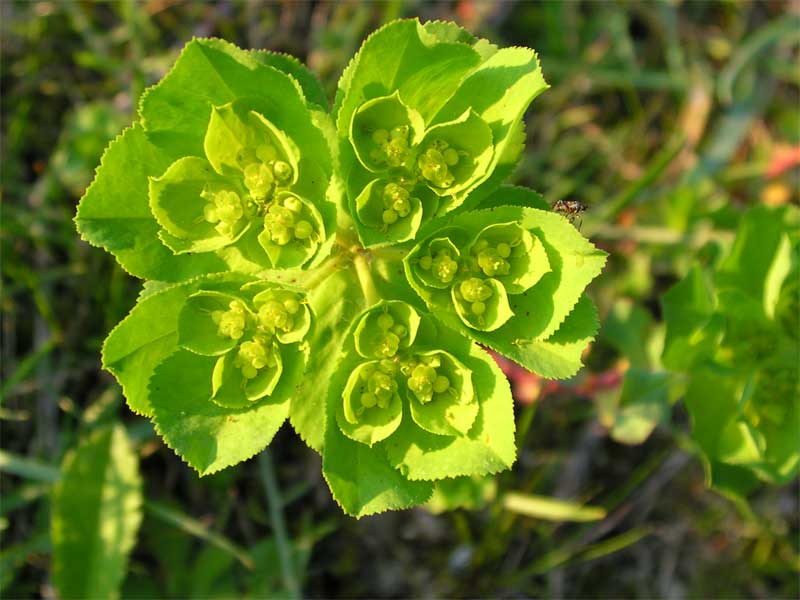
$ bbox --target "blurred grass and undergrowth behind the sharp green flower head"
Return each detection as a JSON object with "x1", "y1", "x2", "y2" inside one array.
[{"x1": 0, "y1": 0, "x2": 800, "y2": 598}]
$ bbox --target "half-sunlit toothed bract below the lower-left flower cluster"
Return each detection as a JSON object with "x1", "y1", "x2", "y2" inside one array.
[{"x1": 150, "y1": 350, "x2": 305, "y2": 475}]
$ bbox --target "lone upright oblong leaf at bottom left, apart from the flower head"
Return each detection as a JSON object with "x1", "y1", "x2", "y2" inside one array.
[{"x1": 51, "y1": 425, "x2": 142, "y2": 598}]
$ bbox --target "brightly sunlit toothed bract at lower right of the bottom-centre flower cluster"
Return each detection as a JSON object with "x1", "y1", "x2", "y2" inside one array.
[{"x1": 382, "y1": 345, "x2": 516, "y2": 480}]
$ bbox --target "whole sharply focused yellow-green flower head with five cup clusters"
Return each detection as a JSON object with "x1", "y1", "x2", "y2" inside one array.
[{"x1": 76, "y1": 20, "x2": 608, "y2": 516}]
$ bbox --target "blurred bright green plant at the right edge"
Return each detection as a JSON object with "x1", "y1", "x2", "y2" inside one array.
[{"x1": 662, "y1": 206, "x2": 800, "y2": 496}]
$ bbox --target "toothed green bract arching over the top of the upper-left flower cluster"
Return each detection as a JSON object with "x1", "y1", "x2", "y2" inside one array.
[{"x1": 139, "y1": 39, "x2": 338, "y2": 251}]
